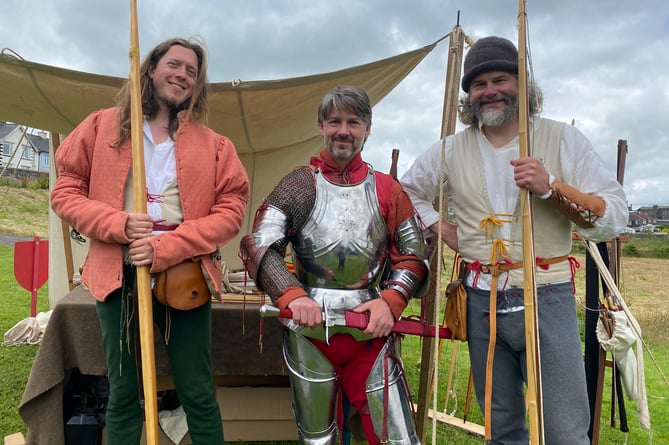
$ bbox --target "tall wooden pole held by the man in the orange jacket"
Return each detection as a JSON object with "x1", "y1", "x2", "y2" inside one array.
[{"x1": 129, "y1": 0, "x2": 158, "y2": 445}]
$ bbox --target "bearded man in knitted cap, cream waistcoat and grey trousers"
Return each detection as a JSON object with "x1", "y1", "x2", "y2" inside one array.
[{"x1": 400, "y1": 37, "x2": 628, "y2": 445}]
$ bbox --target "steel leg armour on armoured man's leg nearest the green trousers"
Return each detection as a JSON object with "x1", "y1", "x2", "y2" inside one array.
[{"x1": 283, "y1": 329, "x2": 339, "y2": 445}]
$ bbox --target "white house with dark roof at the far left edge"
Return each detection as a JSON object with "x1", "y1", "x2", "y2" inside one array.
[{"x1": 0, "y1": 121, "x2": 49, "y2": 173}]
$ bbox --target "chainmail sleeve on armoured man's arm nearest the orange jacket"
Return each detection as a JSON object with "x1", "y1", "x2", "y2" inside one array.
[{"x1": 256, "y1": 167, "x2": 316, "y2": 301}]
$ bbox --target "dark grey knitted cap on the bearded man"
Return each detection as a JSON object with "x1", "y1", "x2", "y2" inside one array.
[{"x1": 462, "y1": 37, "x2": 518, "y2": 92}]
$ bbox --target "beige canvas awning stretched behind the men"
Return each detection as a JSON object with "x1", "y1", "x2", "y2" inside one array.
[{"x1": 0, "y1": 41, "x2": 439, "y2": 305}]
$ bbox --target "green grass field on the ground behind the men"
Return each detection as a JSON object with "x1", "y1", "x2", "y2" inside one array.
[{"x1": 0, "y1": 186, "x2": 669, "y2": 445}]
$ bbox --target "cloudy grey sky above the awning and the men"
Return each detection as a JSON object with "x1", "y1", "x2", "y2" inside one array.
[{"x1": 0, "y1": 0, "x2": 669, "y2": 209}]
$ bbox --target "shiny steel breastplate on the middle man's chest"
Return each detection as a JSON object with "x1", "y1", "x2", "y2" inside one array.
[{"x1": 293, "y1": 171, "x2": 388, "y2": 289}]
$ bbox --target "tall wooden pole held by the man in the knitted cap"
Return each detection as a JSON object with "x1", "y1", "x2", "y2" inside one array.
[{"x1": 518, "y1": 0, "x2": 544, "y2": 445}]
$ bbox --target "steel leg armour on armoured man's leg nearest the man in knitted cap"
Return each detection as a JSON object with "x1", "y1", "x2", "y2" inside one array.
[{"x1": 367, "y1": 335, "x2": 420, "y2": 445}]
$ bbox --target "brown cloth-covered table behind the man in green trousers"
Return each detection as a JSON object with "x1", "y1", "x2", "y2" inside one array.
[{"x1": 19, "y1": 286, "x2": 288, "y2": 445}]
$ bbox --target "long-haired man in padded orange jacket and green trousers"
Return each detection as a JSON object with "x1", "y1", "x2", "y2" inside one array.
[{"x1": 51, "y1": 38, "x2": 249, "y2": 445}]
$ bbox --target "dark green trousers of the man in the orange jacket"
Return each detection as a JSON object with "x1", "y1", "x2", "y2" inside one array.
[{"x1": 96, "y1": 271, "x2": 224, "y2": 445}]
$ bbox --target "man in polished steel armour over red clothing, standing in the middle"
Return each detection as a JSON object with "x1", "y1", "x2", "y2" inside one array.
[{"x1": 241, "y1": 86, "x2": 428, "y2": 445}]
